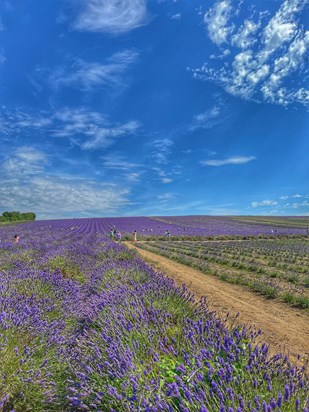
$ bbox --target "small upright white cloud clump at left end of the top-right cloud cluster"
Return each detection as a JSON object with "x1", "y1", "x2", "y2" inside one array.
[{"x1": 204, "y1": 0, "x2": 233, "y2": 46}]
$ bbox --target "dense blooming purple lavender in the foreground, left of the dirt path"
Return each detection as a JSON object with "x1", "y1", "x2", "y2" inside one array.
[{"x1": 0, "y1": 218, "x2": 309, "y2": 412}]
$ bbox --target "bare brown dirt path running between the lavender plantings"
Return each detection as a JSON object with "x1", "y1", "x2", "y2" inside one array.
[{"x1": 124, "y1": 242, "x2": 309, "y2": 360}]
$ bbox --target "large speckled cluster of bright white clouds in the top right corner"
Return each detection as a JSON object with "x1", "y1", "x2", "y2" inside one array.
[{"x1": 193, "y1": 0, "x2": 309, "y2": 105}]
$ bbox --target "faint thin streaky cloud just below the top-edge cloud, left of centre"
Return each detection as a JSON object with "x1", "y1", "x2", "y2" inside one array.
[{"x1": 49, "y1": 50, "x2": 138, "y2": 91}]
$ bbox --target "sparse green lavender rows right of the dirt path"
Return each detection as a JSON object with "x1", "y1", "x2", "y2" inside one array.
[{"x1": 138, "y1": 238, "x2": 309, "y2": 310}]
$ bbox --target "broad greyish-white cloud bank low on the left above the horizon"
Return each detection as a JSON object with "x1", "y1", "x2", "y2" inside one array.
[{"x1": 0, "y1": 146, "x2": 129, "y2": 215}]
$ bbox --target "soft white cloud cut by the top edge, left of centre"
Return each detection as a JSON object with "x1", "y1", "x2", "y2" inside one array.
[{"x1": 73, "y1": 0, "x2": 148, "y2": 34}]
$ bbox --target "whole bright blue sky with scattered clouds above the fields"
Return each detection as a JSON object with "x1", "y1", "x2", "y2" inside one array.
[{"x1": 0, "y1": 0, "x2": 309, "y2": 219}]
